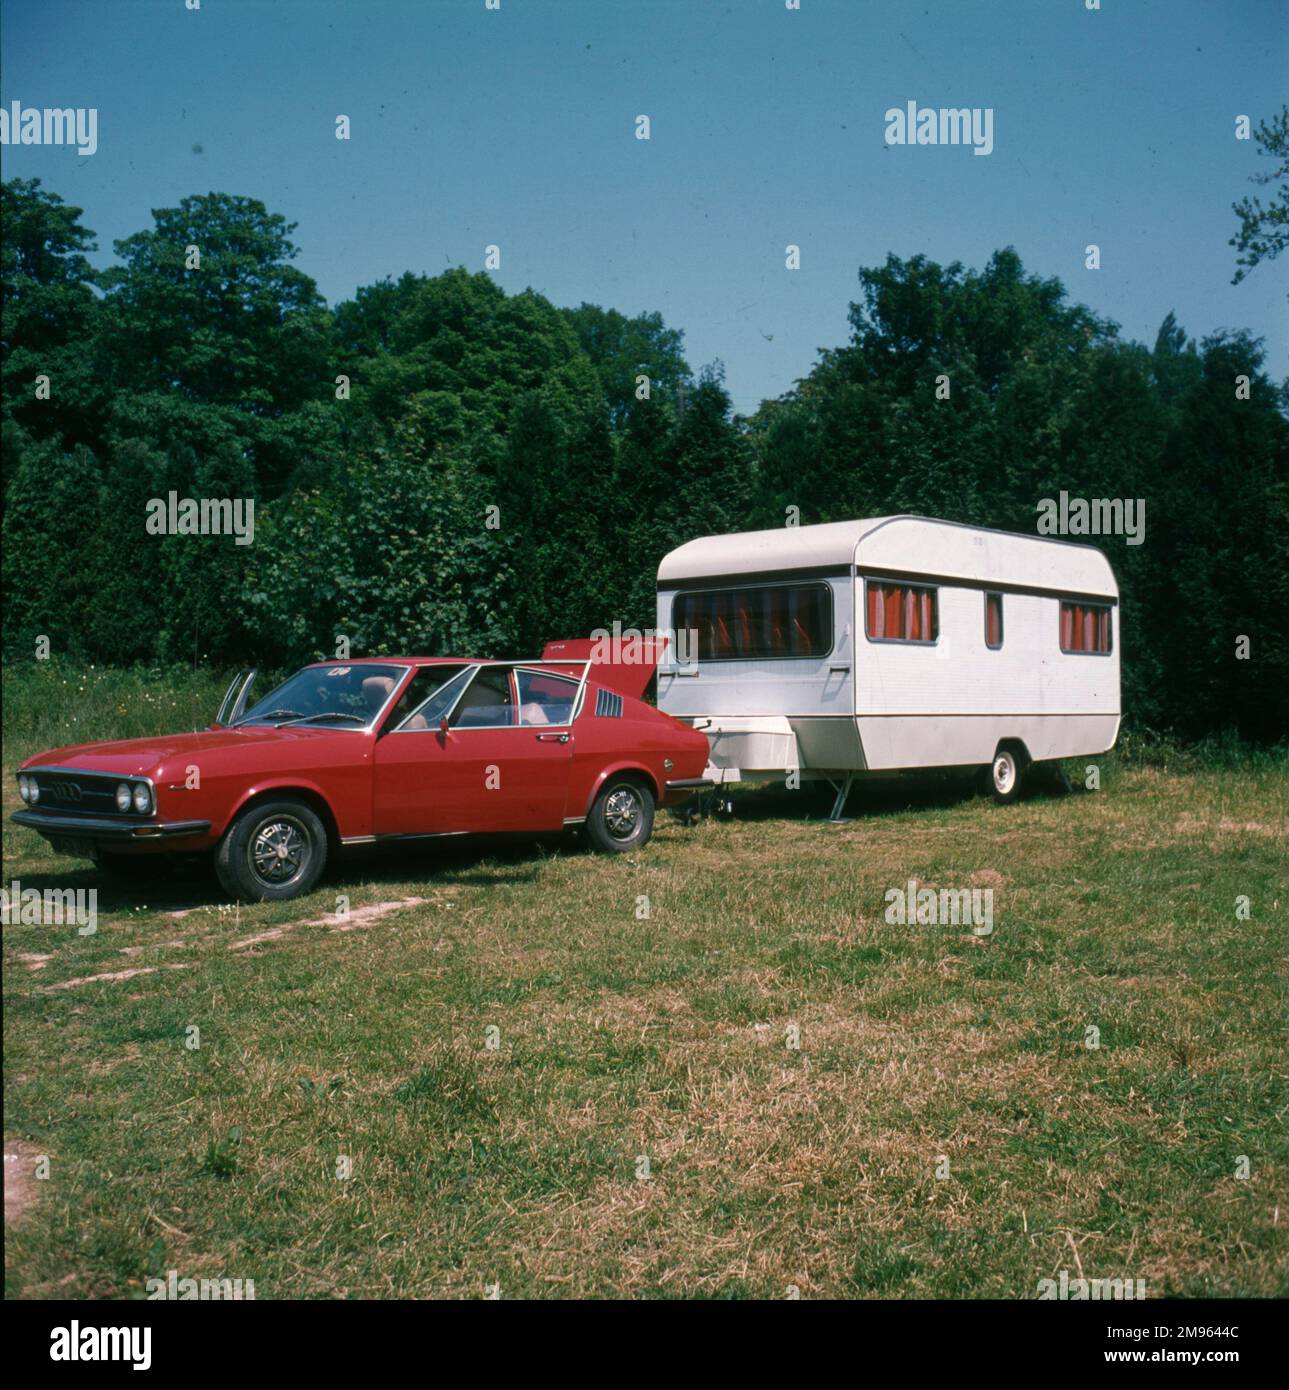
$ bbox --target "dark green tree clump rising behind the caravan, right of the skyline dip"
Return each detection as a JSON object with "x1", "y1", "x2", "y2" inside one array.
[{"x1": 749, "y1": 250, "x2": 1289, "y2": 739}]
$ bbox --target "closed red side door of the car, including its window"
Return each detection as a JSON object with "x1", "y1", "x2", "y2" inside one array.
[{"x1": 374, "y1": 663, "x2": 576, "y2": 835}]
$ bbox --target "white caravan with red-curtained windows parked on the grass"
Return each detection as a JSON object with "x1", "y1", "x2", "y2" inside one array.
[{"x1": 658, "y1": 516, "x2": 1119, "y2": 817}]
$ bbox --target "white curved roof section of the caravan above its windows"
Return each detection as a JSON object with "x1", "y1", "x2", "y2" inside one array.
[{"x1": 658, "y1": 516, "x2": 1119, "y2": 598}]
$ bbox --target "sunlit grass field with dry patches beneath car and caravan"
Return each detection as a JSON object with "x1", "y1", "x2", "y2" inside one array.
[{"x1": 4, "y1": 658, "x2": 1289, "y2": 1298}]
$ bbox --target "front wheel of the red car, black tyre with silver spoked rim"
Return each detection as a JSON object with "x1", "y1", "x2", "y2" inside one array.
[{"x1": 216, "y1": 801, "x2": 327, "y2": 902}]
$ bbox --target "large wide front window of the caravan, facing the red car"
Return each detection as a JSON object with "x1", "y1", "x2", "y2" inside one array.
[{"x1": 672, "y1": 584, "x2": 833, "y2": 662}]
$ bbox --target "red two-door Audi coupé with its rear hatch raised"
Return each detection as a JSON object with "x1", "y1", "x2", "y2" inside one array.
[{"x1": 13, "y1": 641, "x2": 708, "y2": 901}]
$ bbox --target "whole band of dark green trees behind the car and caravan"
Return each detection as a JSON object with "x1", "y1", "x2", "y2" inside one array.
[{"x1": 0, "y1": 186, "x2": 1289, "y2": 739}]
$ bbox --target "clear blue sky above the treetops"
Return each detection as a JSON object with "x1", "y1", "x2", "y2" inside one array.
[{"x1": 0, "y1": 0, "x2": 1289, "y2": 410}]
